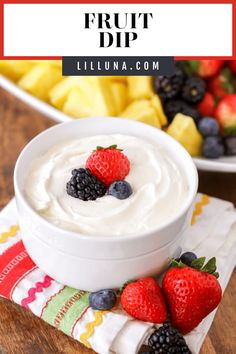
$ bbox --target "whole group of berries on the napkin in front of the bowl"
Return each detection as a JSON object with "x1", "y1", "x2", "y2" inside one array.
[{"x1": 86, "y1": 252, "x2": 222, "y2": 354}]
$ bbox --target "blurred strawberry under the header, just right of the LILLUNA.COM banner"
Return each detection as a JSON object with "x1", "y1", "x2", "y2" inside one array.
[{"x1": 184, "y1": 59, "x2": 225, "y2": 79}]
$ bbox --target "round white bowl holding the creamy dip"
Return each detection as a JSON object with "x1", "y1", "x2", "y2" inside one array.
[{"x1": 14, "y1": 118, "x2": 198, "y2": 291}]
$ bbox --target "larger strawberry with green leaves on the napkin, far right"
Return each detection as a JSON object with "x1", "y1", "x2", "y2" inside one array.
[{"x1": 162, "y1": 257, "x2": 222, "y2": 334}]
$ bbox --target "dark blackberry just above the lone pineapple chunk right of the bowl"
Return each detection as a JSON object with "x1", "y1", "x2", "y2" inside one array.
[{"x1": 164, "y1": 100, "x2": 201, "y2": 123}]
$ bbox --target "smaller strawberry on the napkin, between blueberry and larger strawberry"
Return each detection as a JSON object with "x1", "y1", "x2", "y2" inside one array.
[{"x1": 121, "y1": 277, "x2": 167, "y2": 323}]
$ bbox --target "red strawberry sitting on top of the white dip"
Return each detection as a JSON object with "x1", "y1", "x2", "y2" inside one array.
[{"x1": 86, "y1": 145, "x2": 130, "y2": 186}]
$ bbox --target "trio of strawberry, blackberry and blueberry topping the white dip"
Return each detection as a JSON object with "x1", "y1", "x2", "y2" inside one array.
[{"x1": 66, "y1": 145, "x2": 133, "y2": 201}]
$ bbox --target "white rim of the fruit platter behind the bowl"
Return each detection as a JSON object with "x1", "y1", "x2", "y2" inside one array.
[{"x1": 0, "y1": 75, "x2": 236, "y2": 172}]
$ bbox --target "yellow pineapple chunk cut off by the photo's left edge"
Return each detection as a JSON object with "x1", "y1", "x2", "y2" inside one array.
[{"x1": 0, "y1": 60, "x2": 34, "y2": 81}]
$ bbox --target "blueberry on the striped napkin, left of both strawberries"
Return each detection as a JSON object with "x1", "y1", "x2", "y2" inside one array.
[{"x1": 89, "y1": 289, "x2": 116, "y2": 310}]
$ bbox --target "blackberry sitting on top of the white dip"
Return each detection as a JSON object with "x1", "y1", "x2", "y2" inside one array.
[{"x1": 66, "y1": 168, "x2": 106, "y2": 201}]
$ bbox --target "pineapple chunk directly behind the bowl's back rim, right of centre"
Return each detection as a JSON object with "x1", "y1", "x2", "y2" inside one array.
[{"x1": 120, "y1": 100, "x2": 161, "y2": 129}]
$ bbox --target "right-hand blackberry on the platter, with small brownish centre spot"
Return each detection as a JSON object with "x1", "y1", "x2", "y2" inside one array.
[{"x1": 182, "y1": 77, "x2": 206, "y2": 103}]
